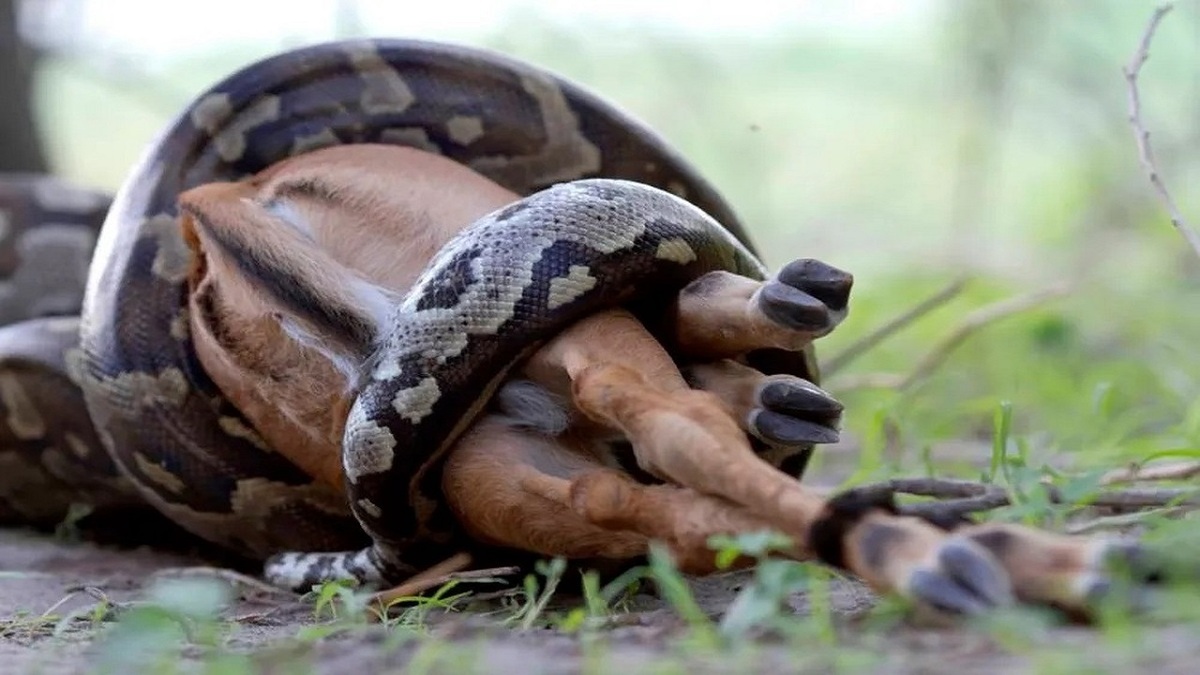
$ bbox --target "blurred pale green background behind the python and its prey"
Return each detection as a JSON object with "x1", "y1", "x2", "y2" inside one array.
[{"x1": 14, "y1": 0, "x2": 1200, "y2": 478}]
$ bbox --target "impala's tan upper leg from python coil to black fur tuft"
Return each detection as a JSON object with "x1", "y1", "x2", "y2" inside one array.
[{"x1": 527, "y1": 311, "x2": 840, "y2": 531}]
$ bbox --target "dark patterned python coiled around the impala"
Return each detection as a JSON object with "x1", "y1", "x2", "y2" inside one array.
[{"x1": 0, "y1": 40, "x2": 811, "y2": 587}]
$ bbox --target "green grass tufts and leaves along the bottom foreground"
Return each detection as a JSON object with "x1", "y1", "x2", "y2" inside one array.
[{"x1": 49, "y1": 511, "x2": 1200, "y2": 675}]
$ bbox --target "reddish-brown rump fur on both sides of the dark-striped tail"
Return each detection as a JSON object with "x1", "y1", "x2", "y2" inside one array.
[{"x1": 180, "y1": 145, "x2": 516, "y2": 489}]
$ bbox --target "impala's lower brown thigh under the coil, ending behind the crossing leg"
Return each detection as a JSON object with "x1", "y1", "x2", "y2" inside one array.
[{"x1": 442, "y1": 416, "x2": 787, "y2": 574}]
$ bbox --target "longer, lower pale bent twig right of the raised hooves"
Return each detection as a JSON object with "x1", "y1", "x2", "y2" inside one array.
[{"x1": 828, "y1": 286, "x2": 1068, "y2": 392}]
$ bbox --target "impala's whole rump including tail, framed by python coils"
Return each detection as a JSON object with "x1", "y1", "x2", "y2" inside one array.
[{"x1": 180, "y1": 145, "x2": 517, "y2": 484}]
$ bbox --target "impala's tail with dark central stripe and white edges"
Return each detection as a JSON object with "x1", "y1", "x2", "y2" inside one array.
[{"x1": 180, "y1": 184, "x2": 397, "y2": 383}]
